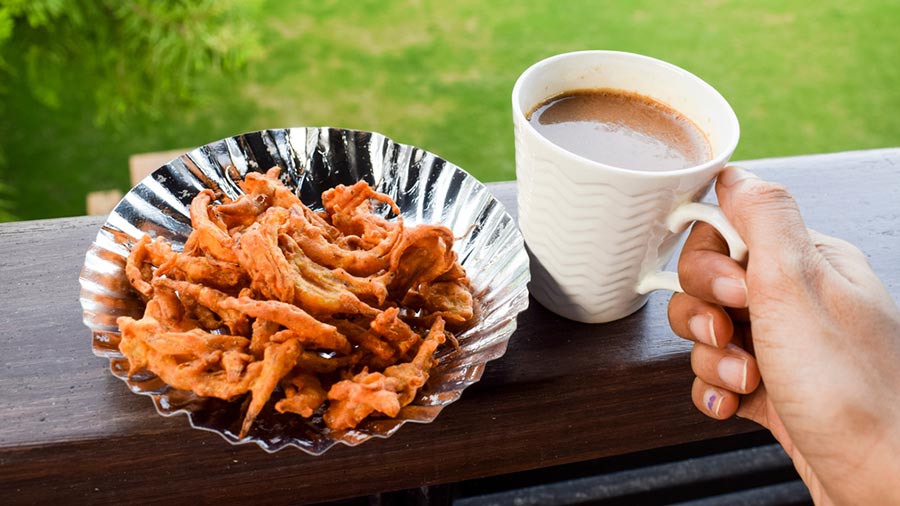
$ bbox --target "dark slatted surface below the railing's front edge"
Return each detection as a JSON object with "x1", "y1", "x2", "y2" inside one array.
[{"x1": 324, "y1": 431, "x2": 812, "y2": 506}]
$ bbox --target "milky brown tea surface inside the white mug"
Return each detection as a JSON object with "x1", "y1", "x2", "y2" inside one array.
[{"x1": 527, "y1": 89, "x2": 712, "y2": 171}]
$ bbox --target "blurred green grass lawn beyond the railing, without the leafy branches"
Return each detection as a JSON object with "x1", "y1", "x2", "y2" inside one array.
[{"x1": 0, "y1": 0, "x2": 900, "y2": 219}]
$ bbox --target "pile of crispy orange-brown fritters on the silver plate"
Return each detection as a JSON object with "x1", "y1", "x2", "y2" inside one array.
[{"x1": 118, "y1": 168, "x2": 473, "y2": 437}]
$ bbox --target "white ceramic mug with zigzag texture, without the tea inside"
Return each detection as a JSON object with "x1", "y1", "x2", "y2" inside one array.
[{"x1": 512, "y1": 51, "x2": 746, "y2": 323}]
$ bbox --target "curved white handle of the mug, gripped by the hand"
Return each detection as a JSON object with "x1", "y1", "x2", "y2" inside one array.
[{"x1": 637, "y1": 202, "x2": 747, "y2": 295}]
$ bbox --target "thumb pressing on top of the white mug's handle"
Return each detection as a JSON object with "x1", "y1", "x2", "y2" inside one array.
[{"x1": 716, "y1": 166, "x2": 815, "y2": 267}]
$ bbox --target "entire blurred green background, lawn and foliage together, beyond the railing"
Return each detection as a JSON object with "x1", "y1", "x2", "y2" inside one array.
[{"x1": 0, "y1": 0, "x2": 900, "y2": 220}]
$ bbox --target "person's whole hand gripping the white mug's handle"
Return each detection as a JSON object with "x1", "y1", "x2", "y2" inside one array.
[{"x1": 669, "y1": 167, "x2": 900, "y2": 504}]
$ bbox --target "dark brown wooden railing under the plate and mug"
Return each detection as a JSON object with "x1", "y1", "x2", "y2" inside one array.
[{"x1": 0, "y1": 149, "x2": 900, "y2": 504}]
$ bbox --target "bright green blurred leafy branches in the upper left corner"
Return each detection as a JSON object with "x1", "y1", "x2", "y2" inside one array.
[{"x1": 0, "y1": 0, "x2": 259, "y2": 124}]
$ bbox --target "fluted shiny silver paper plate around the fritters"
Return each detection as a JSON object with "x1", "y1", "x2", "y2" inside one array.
[{"x1": 79, "y1": 128, "x2": 529, "y2": 455}]
